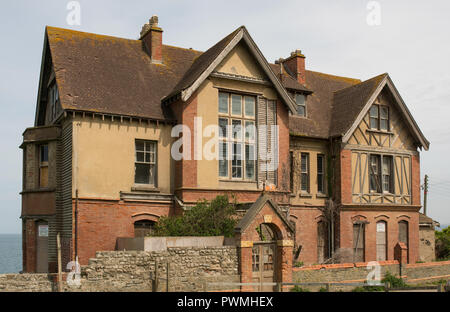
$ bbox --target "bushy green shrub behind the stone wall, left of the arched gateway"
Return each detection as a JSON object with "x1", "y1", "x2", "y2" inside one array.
[{"x1": 153, "y1": 196, "x2": 237, "y2": 237}]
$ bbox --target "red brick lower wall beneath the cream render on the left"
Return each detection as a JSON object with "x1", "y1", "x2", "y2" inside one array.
[{"x1": 73, "y1": 200, "x2": 173, "y2": 265}]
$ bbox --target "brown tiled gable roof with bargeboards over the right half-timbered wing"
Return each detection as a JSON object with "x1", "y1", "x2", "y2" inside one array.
[{"x1": 336, "y1": 73, "x2": 430, "y2": 150}]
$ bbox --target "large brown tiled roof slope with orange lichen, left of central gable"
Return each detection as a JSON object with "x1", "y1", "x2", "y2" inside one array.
[{"x1": 44, "y1": 27, "x2": 201, "y2": 120}]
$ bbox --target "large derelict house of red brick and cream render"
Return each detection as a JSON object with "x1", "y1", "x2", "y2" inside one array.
[{"x1": 21, "y1": 17, "x2": 429, "y2": 282}]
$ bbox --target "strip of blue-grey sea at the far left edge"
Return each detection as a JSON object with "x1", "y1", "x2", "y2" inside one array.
[{"x1": 0, "y1": 234, "x2": 22, "y2": 274}]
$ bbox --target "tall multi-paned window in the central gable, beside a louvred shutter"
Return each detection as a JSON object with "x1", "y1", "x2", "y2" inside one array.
[{"x1": 219, "y1": 92, "x2": 256, "y2": 181}]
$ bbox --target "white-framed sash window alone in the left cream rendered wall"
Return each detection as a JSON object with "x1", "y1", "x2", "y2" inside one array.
[{"x1": 134, "y1": 140, "x2": 156, "y2": 186}]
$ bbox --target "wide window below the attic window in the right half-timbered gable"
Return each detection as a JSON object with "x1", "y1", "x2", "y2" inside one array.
[{"x1": 369, "y1": 155, "x2": 394, "y2": 194}]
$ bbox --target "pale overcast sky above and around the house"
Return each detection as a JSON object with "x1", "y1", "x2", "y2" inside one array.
[{"x1": 0, "y1": 0, "x2": 450, "y2": 233}]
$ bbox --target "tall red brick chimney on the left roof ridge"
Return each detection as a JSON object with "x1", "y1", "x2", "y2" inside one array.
[{"x1": 139, "y1": 15, "x2": 163, "y2": 64}]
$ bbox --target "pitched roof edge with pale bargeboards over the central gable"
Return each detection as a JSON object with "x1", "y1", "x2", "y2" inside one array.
[{"x1": 163, "y1": 26, "x2": 296, "y2": 113}]
